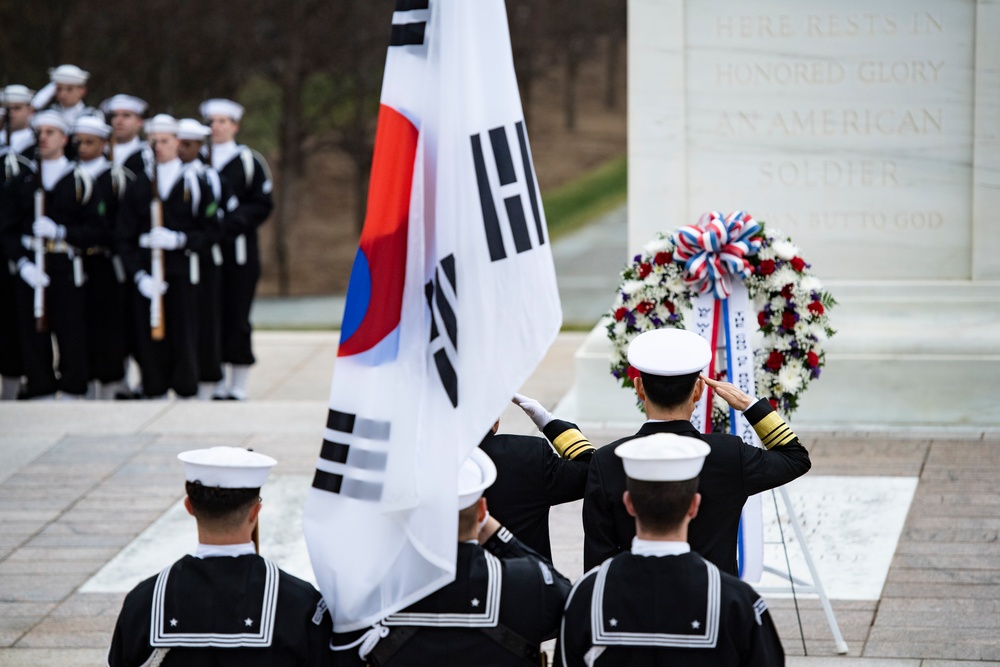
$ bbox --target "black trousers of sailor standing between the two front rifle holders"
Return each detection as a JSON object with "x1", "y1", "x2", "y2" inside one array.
[{"x1": 83, "y1": 254, "x2": 127, "y2": 383}]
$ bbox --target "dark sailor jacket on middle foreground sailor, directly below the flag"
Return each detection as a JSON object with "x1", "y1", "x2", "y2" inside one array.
[{"x1": 333, "y1": 528, "x2": 570, "y2": 667}]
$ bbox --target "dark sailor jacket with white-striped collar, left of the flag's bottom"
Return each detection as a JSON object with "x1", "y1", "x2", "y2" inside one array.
[{"x1": 108, "y1": 554, "x2": 332, "y2": 667}]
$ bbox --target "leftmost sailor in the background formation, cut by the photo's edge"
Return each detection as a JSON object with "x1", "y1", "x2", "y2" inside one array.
[{"x1": 0, "y1": 84, "x2": 36, "y2": 401}]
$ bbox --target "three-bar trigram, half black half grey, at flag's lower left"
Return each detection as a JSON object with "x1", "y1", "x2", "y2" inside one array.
[{"x1": 313, "y1": 410, "x2": 391, "y2": 501}]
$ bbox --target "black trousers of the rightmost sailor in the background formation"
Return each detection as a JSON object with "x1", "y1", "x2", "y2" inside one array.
[{"x1": 222, "y1": 232, "x2": 260, "y2": 366}]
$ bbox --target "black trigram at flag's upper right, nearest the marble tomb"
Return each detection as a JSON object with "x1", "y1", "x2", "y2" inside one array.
[{"x1": 472, "y1": 121, "x2": 545, "y2": 262}]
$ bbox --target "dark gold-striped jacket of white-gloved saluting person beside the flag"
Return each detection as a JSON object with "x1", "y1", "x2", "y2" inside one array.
[{"x1": 479, "y1": 419, "x2": 594, "y2": 560}]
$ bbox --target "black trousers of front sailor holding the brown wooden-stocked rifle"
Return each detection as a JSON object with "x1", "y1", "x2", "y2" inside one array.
[{"x1": 131, "y1": 272, "x2": 198, "y2": 397}]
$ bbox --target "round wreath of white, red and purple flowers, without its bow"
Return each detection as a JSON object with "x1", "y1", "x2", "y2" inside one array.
[{"x1": 607, "y1": 221, "x2": 837, "y2": 433}]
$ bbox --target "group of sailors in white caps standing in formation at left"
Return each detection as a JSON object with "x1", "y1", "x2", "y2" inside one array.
[{"x1": 0, "y1": 65, "x2": 273, "y2": 400}]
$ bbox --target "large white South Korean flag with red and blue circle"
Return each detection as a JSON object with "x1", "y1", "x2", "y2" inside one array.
[{"x1": 303, "y1": 0, "x2": 562, "y2": 632}]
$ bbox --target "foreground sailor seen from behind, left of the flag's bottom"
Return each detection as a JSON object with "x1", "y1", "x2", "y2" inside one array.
[{"x1": 108, "y1": 447, "x2": 332, "y2": 667}]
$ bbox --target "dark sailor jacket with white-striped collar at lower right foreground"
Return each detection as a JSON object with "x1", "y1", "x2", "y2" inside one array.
[{"x1": 555, "y1": 552, "x2": 785, "y2": 667}]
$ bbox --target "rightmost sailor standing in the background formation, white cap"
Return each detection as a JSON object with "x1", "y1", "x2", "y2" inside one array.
[{"x1": 200, "y1": 99, "x2": 274, "y2": 400}]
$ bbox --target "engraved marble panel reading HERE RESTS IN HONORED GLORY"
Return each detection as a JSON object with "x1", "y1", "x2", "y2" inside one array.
[{"x1": 685, "y1": 0, "x2": 975, "y2": 279}]
